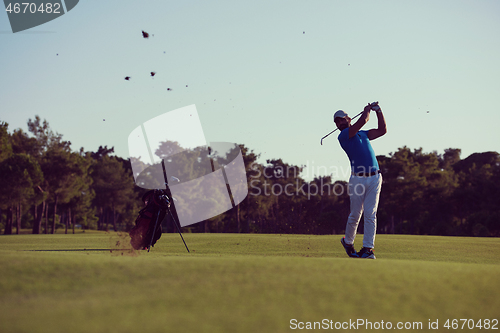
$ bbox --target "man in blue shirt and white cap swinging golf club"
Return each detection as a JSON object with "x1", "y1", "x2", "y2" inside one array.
[{"x1": 333, "y1": 103, "x2": 387, "y2": 259}]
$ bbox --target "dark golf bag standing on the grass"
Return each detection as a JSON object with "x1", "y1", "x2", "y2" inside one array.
[{"x1": 129, "y1": 190, "x2": 168, "y2": 250}]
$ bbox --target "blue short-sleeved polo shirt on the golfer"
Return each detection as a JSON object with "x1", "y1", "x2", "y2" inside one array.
[{"x1": 338, "y1": 128, "x2": 379, "y2": 173}]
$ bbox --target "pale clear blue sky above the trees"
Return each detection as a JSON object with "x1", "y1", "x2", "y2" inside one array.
[{"x1": 0, "y1": 0, "x2": 500, "y2": 180}]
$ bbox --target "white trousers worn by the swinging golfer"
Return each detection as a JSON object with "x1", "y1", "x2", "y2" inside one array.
[{"x1": 345, "y1": 174, "x2": 382, "y2": 248}]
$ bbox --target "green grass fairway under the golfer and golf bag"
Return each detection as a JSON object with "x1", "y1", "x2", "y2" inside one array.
[{"x1": 0, "y1": 232, "x2": 500, "y2": 333}]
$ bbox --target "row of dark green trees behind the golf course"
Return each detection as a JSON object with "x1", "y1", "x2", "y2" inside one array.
[{"x1": 0, "y1": 116, "x2": 500, "y2": 237}]
